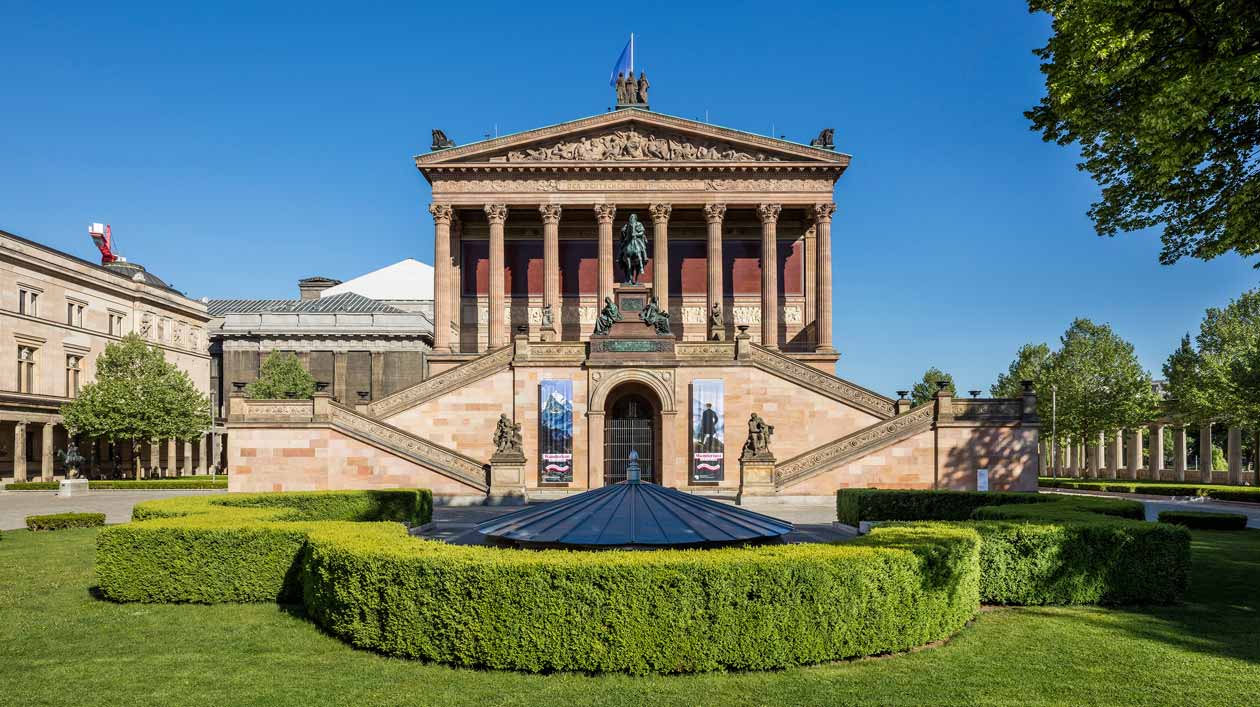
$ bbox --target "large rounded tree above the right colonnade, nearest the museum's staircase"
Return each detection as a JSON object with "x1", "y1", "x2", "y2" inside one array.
[{"x1": 1043, "y1": 319, "x2": 1158, "y2": 444}]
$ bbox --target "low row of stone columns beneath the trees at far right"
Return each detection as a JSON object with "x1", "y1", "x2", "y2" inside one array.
[{"x1": 1048, "y1": 422, "x2": 1260, "y2": 484}]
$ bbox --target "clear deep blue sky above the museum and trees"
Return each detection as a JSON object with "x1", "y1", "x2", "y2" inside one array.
[{"x1": 0, "y1": 0, "x2": 1260, "y2": 393}]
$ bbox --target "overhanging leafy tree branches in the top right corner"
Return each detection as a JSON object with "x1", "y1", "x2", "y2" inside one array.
[{"x1": 1024, "y1": 0, "x2": 1260, "y2": 267}]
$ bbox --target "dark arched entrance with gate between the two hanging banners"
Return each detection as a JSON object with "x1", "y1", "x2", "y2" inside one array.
[{"x1": 604, "y1": 383, "x2": 660, "y2": 484}]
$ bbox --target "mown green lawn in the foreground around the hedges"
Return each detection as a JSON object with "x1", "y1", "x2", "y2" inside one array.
[{"x1": 0, "y1": 529, "x2": 1260, "y2": 707}]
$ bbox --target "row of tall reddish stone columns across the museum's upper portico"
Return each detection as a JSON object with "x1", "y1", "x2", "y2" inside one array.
[{"x1": 428, "y1": 203, "x2": 835, "y2": 353}]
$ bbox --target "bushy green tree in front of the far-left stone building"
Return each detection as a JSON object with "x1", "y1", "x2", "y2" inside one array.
[{"x1": 62, "y1": 334, "x2": 210, "y2": 479}]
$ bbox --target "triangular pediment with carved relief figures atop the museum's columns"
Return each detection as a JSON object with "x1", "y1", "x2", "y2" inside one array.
[{"x1": 416, "y1": 108, "x2": 849, "y2": 169}]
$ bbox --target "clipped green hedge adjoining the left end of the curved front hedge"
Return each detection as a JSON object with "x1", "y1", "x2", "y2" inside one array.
[{"x1": 96, "y1": 489, "x2": 432, "y2": 604}]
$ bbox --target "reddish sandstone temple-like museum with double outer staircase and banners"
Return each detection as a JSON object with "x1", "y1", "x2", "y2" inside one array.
[{"x1": 228, "y1": 97, "x2": 1038, "y2": 502}]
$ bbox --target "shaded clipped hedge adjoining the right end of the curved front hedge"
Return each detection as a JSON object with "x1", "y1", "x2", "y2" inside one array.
[{"x1": 837, "y1": 489, "x2": 1189, "y2": 605}]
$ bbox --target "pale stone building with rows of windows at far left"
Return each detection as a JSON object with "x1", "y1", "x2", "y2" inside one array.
[{"x1": 0, "y1": 231, "x2": 222, "y2": 481}]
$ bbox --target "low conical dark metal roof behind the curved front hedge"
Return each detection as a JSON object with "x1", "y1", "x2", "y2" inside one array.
[{"x1": 476, "y1": 481, "x2": 793, "y2": 547}]
